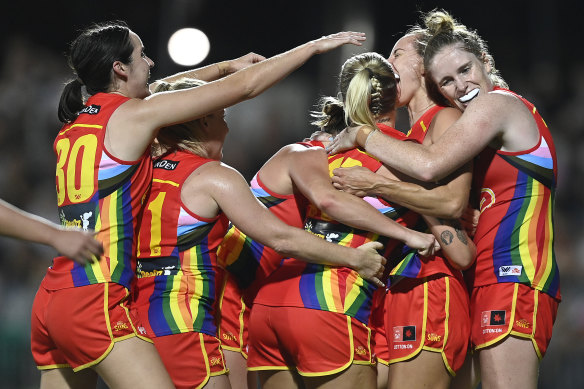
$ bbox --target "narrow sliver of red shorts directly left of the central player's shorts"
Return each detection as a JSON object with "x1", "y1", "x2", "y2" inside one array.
[{"x1": 217, "y1": 275, "x2": 249, "y2": 358}]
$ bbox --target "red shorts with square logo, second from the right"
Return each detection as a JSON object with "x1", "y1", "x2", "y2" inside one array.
[{"x1": 385, "y1": 275, "x2": 470, "y2": 375}]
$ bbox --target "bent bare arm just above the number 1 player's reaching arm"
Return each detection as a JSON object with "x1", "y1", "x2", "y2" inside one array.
[{"x1": 287, "y1": 146, "x2": 434, "y2": 255}]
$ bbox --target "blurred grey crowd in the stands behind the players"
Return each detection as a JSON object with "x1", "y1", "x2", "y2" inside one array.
[{"x1": 0, "y1": 33, "x2": 584, "y2": 388}]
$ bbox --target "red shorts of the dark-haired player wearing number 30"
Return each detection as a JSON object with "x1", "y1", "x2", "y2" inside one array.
[{"x1": 31, "y1": 283, "x2": 151, "y2": 371}]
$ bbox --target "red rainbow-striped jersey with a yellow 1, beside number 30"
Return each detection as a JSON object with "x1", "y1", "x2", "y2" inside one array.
[{"x1": 135, "y1": 151, "x2": 228, "y2": 336}]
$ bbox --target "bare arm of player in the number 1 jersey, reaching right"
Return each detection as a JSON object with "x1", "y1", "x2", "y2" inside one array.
[{"x1": 182, "y1": 163, "x2": 386, "y2": 286}]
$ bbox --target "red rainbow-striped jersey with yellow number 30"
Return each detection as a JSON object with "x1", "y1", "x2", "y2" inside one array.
[{"x1": 43, "y1": 93, "x2": 152, "y2": 289}]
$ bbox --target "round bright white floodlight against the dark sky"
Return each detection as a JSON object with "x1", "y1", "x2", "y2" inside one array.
[{"x1": 168, "y1": 28, "x2": 210, "y2": 66}]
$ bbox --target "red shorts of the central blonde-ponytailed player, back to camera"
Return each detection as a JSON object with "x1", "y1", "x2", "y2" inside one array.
[{"x1": 247, "y1": 303, "x2": 375, "y2": 376}]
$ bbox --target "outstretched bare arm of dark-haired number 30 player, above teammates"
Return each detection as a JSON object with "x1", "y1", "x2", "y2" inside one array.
[{"x1": 105, "y1": 32, "x2": 365, "y2": 160}]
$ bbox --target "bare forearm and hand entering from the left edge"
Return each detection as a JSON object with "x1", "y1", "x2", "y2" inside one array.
[{"x1": 0, "y1": 200, "x2": 103, "y2": 264}]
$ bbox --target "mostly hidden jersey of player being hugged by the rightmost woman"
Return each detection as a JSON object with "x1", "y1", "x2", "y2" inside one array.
[{"x1": 390, "y1": 106, "x2": 458, "y2": 279}]
